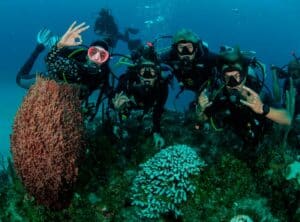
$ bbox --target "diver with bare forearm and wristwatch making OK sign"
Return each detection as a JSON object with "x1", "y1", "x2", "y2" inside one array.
[{"x1": 196, "y1": 47, "x2": 291, "y2": 147}]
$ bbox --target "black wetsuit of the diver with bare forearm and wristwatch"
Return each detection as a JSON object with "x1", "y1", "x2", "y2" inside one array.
[{"x1": 204, "y1": 77, "x2": 278, "y2": 146}]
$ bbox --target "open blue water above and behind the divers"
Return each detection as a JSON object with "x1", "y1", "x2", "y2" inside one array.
[{"x1": 0, "y1": 0, "x2": 300, "y2": 161}]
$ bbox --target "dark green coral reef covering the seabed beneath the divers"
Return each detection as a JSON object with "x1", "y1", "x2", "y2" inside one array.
[{"x1": 0, "y1": 111, "x2": 300, "y2": 222}]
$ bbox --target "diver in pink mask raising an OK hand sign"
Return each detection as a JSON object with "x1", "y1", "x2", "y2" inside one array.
[{"x1": 46, "y1": 22, "x2": 112, "y2": 121}]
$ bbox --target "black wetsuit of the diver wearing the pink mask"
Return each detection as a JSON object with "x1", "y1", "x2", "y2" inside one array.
[{"x1": 46, "y1": 47, "x2": 111, "y2": 119}]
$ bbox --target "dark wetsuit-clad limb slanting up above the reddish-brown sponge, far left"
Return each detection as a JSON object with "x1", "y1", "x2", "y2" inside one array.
[{"x1": 16, "y1": 44, "x2": 45, "y2": 89}]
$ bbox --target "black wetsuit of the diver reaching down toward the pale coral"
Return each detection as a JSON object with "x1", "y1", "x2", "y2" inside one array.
[{"x1": 116, "y1": 68, "x2": 168, "y2": 133}]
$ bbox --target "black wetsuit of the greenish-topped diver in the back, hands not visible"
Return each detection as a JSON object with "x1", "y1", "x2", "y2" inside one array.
[{"x1": 160, "y1": 43, "x2": 218, "y2": 93}]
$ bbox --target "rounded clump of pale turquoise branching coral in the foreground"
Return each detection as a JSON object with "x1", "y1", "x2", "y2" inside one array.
[{"x1": 132, "y1": 145, "x2": 205, "y2": 218}]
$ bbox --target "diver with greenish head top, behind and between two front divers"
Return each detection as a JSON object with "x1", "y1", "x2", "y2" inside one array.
[{"x1": 160, "y1": 29, "x2": 218, "y2": 97}]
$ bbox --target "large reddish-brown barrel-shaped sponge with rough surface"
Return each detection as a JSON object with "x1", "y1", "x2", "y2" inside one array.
[{"x1": 11, "y1": 78, "x2": 84, "y2": 210}]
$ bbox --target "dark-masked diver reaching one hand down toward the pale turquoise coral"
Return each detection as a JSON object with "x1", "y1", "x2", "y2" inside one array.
[{"x1": 112, "y1": 42, "x2": 168, "y2": 147}]
